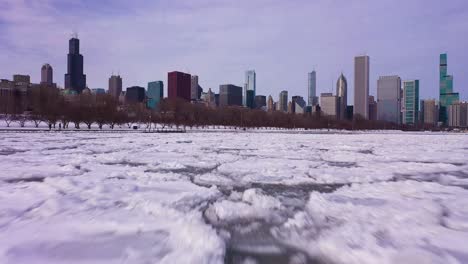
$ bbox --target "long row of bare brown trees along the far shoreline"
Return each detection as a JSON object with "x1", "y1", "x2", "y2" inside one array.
[{"x1": 0, "y1": 86, "x2": 438, "y2": 130}]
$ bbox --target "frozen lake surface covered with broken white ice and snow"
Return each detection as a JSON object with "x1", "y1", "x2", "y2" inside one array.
[{"x1": 0, "y1": 132, "x2": 468, "y2": 264}]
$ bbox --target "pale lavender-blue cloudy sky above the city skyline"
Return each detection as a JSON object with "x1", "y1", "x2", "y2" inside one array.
[{"x1": 0, "y1": 0, "x2": 468, "y2": 101}]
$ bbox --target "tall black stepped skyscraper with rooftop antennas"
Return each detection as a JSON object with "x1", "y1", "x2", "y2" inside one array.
[{"x1": 65, "y1": 37, "x2": 86, "y2": 93}]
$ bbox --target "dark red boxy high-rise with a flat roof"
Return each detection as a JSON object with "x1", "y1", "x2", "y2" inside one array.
[{"x1": 167, "y1": 71, "x2": 192, "y2": 102}]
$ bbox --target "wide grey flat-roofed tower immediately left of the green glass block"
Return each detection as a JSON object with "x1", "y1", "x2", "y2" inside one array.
[{"x1": 377, "y1": 76, "x2": 401, "y2": 124}]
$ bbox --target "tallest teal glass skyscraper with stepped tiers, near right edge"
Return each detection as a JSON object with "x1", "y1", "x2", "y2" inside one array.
[{"x1": 439, "y1": 54, "x2": 460, "y2": 124}]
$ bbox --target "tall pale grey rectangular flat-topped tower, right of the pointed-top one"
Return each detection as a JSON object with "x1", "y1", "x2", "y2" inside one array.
[{"x1": 354, "y1": 56, "x2": 369, "y2": 119}]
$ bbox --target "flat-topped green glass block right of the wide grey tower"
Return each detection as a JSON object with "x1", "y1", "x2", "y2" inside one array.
[{"x1": 403, "y1": 80, "x2": 419, "y2": 125}]
